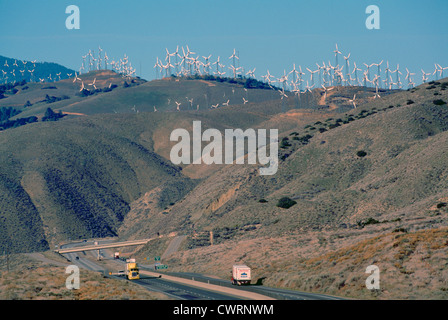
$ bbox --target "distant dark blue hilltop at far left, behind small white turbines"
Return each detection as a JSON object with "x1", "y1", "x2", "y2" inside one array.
[{"x1": 0, "y1": 55, "x2": 75, "y2": 84}]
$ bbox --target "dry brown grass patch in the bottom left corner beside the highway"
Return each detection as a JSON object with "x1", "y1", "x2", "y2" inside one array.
[{"x1": 0, "y1": 253, "x2": 167, "y2": 300}]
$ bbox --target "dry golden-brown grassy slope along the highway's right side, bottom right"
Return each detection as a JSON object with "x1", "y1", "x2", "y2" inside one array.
[{"x1": 160, "y1": 228, "x2": 448, "y2": 299}]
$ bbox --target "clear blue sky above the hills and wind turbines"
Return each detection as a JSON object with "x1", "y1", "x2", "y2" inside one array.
[{"x1": 0, "y1": 0, "x2": 448, "y2": 83}]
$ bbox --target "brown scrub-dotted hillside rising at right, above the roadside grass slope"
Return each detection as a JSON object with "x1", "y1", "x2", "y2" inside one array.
[{"x1": 119, "y1": 80, "x2": 448, "y2": 239}]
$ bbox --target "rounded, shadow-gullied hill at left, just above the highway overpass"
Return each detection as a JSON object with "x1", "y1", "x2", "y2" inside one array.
[{"x1": 0, "y1": 115, "x2": 198, "y2": 251}]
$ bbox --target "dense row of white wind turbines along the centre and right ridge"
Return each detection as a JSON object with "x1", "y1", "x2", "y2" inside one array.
[{"x1": 154, "y1": 44, "x2": 448, "y2": 93}]
